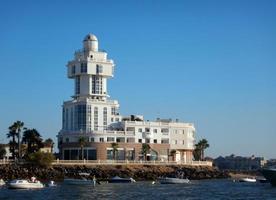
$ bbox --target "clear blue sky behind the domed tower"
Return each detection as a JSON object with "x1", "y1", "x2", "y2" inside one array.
[{"x1": 0, "y1": 0, "x2": 276, "y2": 158}]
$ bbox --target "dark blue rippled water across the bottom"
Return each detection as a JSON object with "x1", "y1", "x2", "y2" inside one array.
[{"x1": 0, "y1": 180, "x2": 276, "y2": 200}]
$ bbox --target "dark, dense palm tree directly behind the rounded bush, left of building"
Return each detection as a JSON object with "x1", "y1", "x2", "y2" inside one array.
[{"x1": 22, "y1": 129, "x2": 43, "y2": 154}]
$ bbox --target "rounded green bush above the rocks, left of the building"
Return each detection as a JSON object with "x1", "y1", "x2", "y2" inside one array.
[{"x1": 27, "y1": 151, "x2": 55, "y2": 168}]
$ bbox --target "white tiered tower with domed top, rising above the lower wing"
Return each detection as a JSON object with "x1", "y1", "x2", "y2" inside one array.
[{"x1": 61, "y1": 34, "x2": 121, "y2": 134}]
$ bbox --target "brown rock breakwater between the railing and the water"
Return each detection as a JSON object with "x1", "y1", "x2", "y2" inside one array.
[{"x1": 0, "y1": 165, "x2": 229, "y2": 181}]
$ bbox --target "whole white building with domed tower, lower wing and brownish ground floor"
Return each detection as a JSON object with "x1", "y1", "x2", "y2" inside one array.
[{"x1": 58, "y1": 34, "x2": 195, "y2": 161}]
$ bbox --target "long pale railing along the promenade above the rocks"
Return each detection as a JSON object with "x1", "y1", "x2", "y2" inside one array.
[{"x1": 53, "y1": 160, "x2": 213, "y2": 166}]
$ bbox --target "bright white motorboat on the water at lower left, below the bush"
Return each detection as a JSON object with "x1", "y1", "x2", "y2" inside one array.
[{"x1": 8, "y1": 179, "x2": 44, "y2": 189}]
